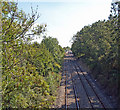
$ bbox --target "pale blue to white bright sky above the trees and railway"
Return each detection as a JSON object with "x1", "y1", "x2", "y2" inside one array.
[{"x1": 17, "y1": 0, "x2": 112, "y2": 47}]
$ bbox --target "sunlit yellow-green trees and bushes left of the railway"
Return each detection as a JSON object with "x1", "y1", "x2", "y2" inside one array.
[{"x1": 2, "y1": 2, "x2": 64, "y2": 108}]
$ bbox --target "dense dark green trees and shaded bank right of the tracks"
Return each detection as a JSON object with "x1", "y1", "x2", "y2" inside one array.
[{"x1": 72, "y1": 2, "x2": 120, "y2": 101}]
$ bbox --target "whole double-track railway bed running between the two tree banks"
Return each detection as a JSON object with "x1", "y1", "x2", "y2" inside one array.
[{"x1": 64, "y1": 54, "x2": 113, "y2": 110}]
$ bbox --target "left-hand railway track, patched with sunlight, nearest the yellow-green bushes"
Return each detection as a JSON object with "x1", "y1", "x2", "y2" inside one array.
[{"x1": 64, "y1": 60, "x2": 79, "y2": 110}]
